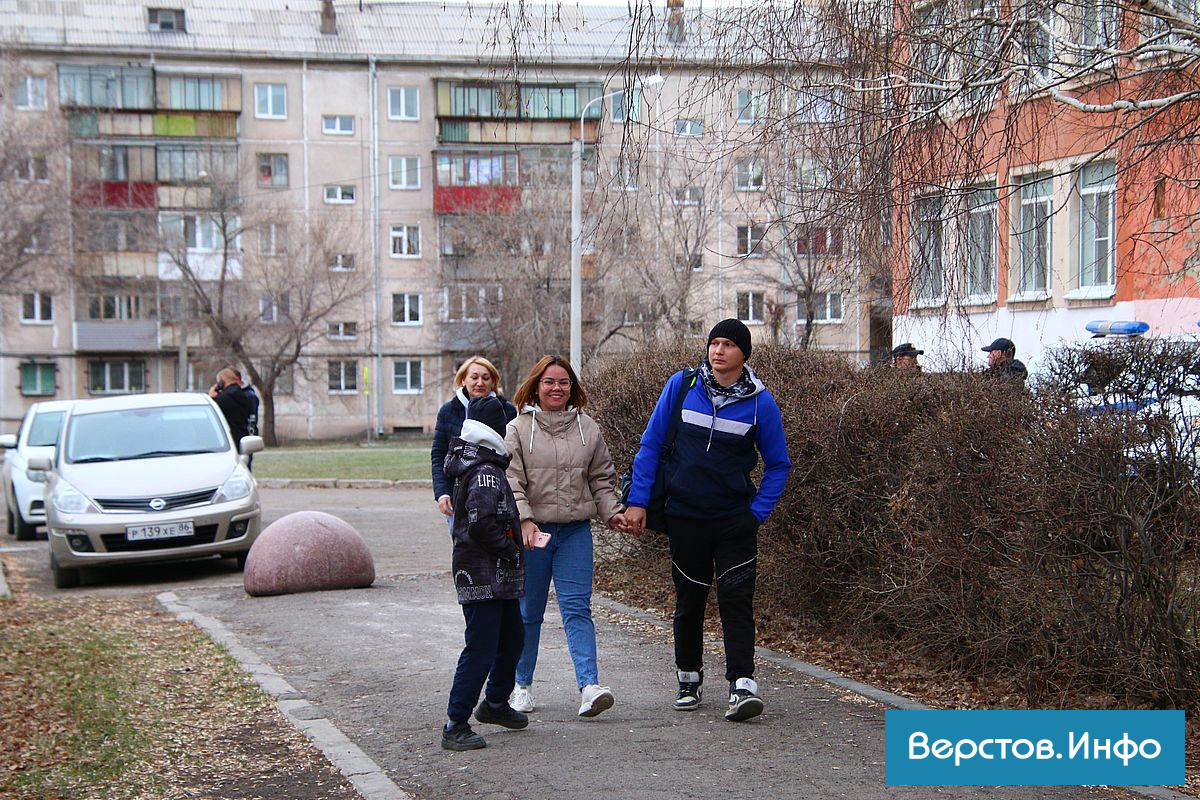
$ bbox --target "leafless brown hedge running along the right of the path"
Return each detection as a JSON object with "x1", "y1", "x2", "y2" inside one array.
[{"x1": 589, "y1": 342, "x2": 1200, "y2": 706}]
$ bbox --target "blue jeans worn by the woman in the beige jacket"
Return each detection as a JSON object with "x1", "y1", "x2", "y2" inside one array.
[{"x1": 517, "y1": 519, "x2": 599, "y2": 688}]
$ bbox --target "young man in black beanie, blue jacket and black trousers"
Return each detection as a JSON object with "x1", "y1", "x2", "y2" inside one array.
[{"x1": 625, "y1": 319, "x2": 792, "y2": 722}]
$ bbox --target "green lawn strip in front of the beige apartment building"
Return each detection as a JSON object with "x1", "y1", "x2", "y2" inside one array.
[{"x1": 254, "y1": 443, "x2": 430, "y2": 481}]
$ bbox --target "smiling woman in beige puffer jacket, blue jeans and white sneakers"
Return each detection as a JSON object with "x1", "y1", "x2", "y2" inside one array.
[{"x1": 505, "y1": 355, "x2": 625, "y2": 717}]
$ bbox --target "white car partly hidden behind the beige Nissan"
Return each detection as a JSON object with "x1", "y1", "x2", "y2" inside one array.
[{"x1": 0, "y1": 401, "x2": 72, "y2": 540}]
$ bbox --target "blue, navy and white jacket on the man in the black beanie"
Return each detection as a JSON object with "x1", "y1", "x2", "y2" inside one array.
[{"x1": 629, "y1": 367, "x2": 792, "y2": 522}]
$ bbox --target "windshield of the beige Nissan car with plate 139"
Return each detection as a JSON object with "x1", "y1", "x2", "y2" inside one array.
[{"x1": 66, "y1": 405, "x2": 229, "y2": 464}]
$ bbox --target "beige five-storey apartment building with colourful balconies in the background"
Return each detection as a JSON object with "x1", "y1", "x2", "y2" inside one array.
[{"x1": 0, "y1": 0, "x2": 886, "y2": 439}]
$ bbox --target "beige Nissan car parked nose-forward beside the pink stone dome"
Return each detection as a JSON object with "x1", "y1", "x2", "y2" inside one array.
[{"x1": 29, "y1": 393, "x2": 263, "y2": 589}]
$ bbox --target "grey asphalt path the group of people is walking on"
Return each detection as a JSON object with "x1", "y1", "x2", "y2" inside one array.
[{"x1": 154, "y1": 489, "x2": 1181, "y2": 800}]
